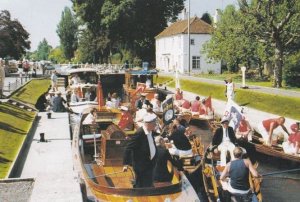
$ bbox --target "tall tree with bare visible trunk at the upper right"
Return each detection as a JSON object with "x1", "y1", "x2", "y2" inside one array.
[{"x1": 239, "y1": 0, "x2": 300, "y2": 88}]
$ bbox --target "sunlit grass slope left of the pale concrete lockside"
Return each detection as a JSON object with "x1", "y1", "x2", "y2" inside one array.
[{"x1": 0, "y1": 79, "x2": 50, "y2": 179}]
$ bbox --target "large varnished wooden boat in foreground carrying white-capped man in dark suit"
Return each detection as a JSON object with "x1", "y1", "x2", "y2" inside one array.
[{"x1": 72, "y1": 109, "x2": 198, "y2": 201}]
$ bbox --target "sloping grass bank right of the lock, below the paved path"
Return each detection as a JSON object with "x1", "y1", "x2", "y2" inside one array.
[{"x1": 157, "y1": 76, "x2": 300, "y2": 120}]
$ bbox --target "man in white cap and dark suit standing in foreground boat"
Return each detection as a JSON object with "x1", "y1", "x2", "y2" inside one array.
[{"x1": 123, "y1": 114, "x2": 158, "y2": 188}]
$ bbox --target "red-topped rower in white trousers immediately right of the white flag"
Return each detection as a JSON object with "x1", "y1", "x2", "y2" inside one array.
[{"x1": 235, "y1": 116, "x2": 253, "y2": 142}]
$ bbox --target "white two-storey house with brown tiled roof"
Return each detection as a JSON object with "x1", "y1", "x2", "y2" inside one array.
[{"x1": 155, "y1": 17, "x2": 221, "y2": 73}]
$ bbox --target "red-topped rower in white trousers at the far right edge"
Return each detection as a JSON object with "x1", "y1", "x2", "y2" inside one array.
[{"x1": 282, "y1": 123, "x2": 300, "y2": 154}]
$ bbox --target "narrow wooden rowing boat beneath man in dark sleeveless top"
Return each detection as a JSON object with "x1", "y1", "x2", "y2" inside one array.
[{"x1": 202, "y1": 148, "x2": 262, "y2": 202}]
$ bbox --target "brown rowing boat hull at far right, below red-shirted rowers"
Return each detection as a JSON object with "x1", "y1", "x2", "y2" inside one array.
[{"x1": 249, "y1": 133, "x2": 300, "y2": 163}]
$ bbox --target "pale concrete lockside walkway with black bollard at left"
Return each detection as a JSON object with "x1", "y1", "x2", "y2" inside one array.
[{"x1": 21, "y1": 112, "x2": 82, "y2": 202}]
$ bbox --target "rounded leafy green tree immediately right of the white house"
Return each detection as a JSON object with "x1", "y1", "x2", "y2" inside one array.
[{"x1": 203, "y1": 5, "x2": 267, "y2": 75}]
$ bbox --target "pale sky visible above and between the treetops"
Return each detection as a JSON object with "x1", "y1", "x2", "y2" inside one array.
[{"x1": 0, "y1": 0, "x2": 237, "y2": 50}]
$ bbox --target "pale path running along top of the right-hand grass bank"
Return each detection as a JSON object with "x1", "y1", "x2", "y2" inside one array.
[{"x1": 159, "y1": 73, "x2": 300, "y2": 98}]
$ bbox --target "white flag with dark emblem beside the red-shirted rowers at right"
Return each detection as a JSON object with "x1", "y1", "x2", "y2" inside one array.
[{"x1": 223, "y1": 100, "x2": 243, "y2": 130}]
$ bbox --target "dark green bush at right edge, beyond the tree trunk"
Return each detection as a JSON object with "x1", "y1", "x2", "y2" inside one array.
[{"x1": 284, "y1": 52, "x2": 300, "y2": 87}]
